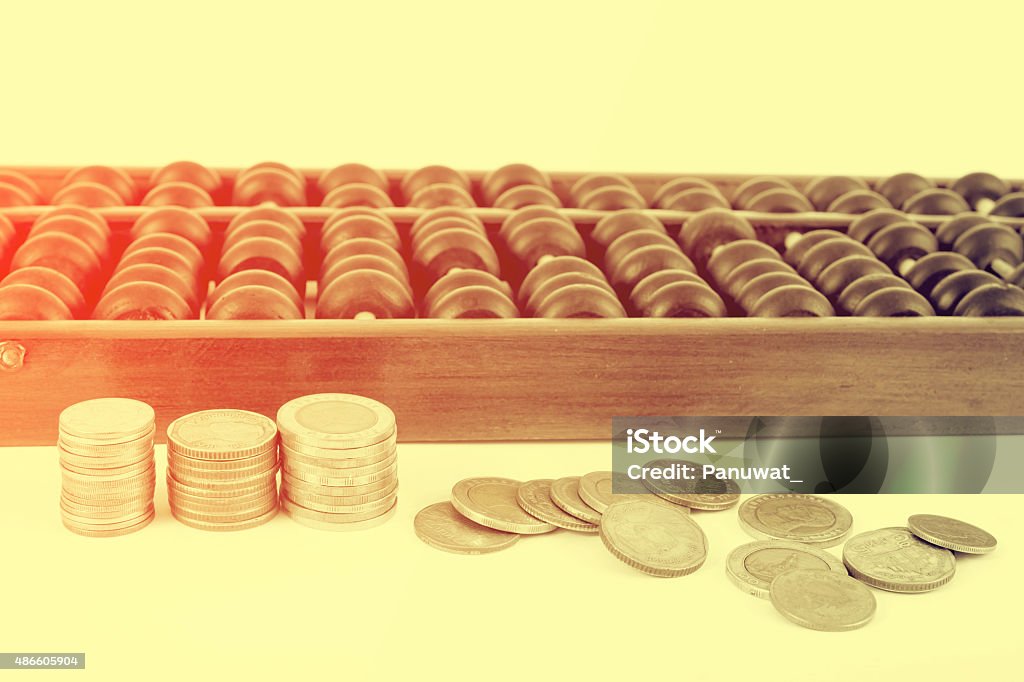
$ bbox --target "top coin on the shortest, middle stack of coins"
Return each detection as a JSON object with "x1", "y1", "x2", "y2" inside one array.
[{"x1": 167, "y1": 410, "x2": 278, "y2": 460}]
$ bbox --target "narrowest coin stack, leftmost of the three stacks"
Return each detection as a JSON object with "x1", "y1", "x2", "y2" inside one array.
[{"x1": 57, "y1": 398, "x2": 157, "y2": 538}]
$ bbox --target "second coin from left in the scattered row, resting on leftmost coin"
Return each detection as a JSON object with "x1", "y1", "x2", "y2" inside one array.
[{"x1": 452, "y1": 477, "x2": 555, "y2": 535}]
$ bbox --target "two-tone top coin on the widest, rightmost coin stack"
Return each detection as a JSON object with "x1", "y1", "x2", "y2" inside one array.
[{"x1": 278, "y1": 393, "x2": 395, "y2": 449}]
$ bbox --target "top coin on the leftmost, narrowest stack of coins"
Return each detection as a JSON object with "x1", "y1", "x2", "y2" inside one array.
[{"x1": 58, "y1": 398, "x2": 156, "y2": 444}]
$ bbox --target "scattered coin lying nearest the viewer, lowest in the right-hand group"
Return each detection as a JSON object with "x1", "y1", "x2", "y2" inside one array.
[{"x1": 770, "y1": 568, "x2": 874, "y2": 632}]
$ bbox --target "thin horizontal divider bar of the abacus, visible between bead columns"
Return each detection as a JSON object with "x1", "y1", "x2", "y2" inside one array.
[{"x1": 8, "y1": 206, "x2": 1024, "y2": 231}]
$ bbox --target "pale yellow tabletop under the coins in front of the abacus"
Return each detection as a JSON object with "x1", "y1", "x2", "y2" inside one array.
[{"x1": 0, "y1": 441, "x2": 1024, "y2": 680}]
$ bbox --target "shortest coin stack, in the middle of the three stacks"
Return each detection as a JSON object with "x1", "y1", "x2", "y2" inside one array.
[{"x1": 167, "y1": 410, "x2": 279, "y2": 530}]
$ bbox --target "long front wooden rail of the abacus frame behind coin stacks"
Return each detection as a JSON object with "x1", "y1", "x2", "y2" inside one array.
[{"x1": 0, "y1": 318, "x2": 1024, "y2": 445}]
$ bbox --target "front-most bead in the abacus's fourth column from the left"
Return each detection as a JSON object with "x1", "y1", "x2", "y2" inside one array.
[{"x1": 316, "y1": 269, "x2": 416, "y2": 319}]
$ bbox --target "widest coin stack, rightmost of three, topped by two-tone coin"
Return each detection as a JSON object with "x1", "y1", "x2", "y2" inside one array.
[{"x1": 278, "y1": 393, "x2": 398, "y2": 530}]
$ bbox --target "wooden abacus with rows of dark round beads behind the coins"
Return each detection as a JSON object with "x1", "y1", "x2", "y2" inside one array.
[{"x1": 0, "y1": 162, "x2": 1024, "y2": 444}]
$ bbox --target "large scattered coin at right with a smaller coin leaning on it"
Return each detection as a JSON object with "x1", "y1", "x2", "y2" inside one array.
[{"x1": 843, "y1": 527, "x2": 956, "y2": 592}]
